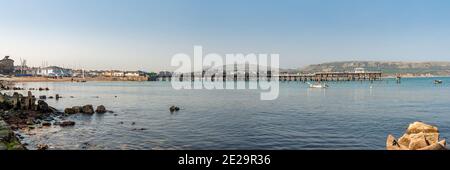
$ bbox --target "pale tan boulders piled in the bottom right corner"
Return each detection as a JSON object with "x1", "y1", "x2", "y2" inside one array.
[{"x1": 386, "y1": 122, "x2": 446, "y2": 150}]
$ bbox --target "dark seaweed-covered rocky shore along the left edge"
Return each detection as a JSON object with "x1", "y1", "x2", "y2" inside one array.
[{"x1": 0, "y1": 82, "x2": 112, "y2": 150}]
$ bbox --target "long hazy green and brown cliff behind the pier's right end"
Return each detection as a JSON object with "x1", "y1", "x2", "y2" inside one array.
[{"x1": 299, "y1": 61, "x2": 450, "y2": 76}]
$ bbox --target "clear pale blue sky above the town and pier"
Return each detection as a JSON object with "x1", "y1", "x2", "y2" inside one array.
[{"x1": 0, "y1": 0, "x2": 450, "y2": 71}]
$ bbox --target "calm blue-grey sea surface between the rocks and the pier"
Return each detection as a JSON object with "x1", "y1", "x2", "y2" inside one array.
[{"x1": 7, "y1": 78, "x2": 450, "y2": 150}]
